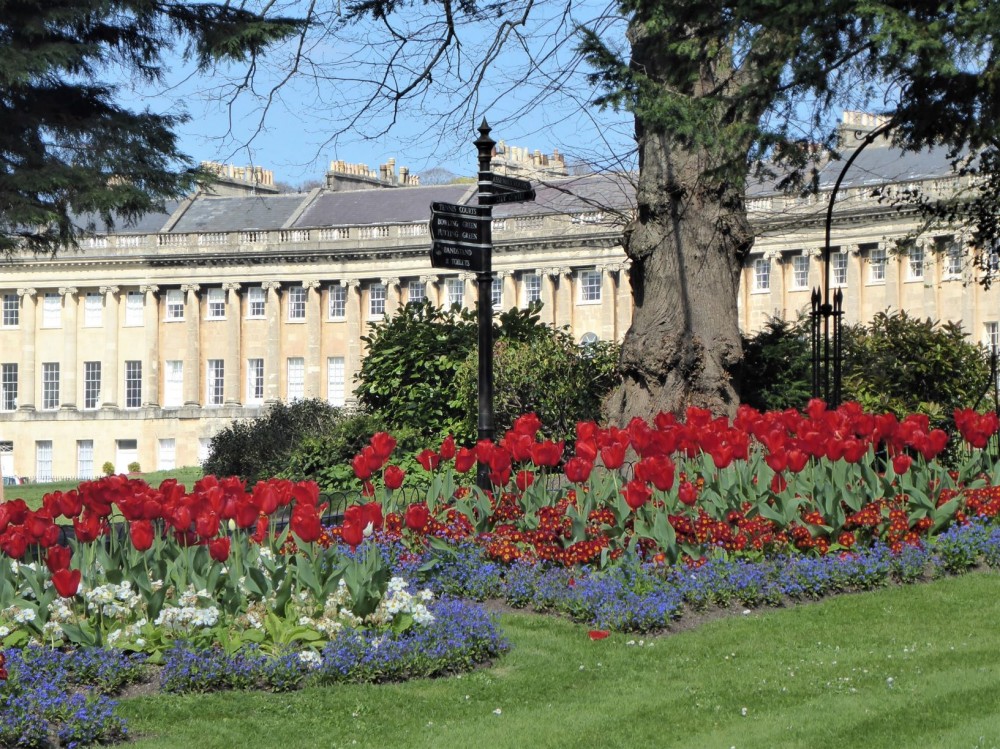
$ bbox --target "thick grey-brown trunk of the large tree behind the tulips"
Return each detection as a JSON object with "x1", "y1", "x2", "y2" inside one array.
[{"x1": 605, "y1": 20, "x2": 753, "y2": 424}]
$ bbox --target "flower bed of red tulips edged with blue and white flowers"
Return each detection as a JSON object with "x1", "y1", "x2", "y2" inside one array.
[{"x1": 0, "y1": 402, "x2": 1000, "y2": 745}]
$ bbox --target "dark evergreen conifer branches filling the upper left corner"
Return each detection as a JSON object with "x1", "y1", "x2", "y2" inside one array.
[{"x1": 0, "y1": 0, "x2": 302, "y2": 255}]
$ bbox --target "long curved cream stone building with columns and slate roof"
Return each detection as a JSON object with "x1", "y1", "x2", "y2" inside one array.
[{"x1": 0, "y1": 113, "x2": 1000, "y2": 481}]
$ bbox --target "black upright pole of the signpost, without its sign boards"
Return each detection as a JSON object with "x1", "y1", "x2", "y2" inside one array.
[{"x1": 473, "y1": 117, "x2": 496, "y2": 490}]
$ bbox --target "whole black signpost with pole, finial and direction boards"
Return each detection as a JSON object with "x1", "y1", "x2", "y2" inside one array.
[{"x1": 431, "y1": 118, "x2": 535, "y2": 490}]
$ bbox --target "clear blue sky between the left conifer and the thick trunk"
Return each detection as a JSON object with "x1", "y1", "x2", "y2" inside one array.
[{"x1": 127, "y1": 3, "x2": 634, "y2": 185}]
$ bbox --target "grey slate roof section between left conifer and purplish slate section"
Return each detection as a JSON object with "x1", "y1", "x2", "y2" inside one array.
[{"x1": 171, "y1": 193, "x2": 307, "y2": 234}]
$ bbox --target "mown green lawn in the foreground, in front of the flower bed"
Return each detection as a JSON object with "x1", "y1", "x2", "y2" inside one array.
[{"x1": 121, "y1": 572, "x2": 1000, "y2": 749}]
